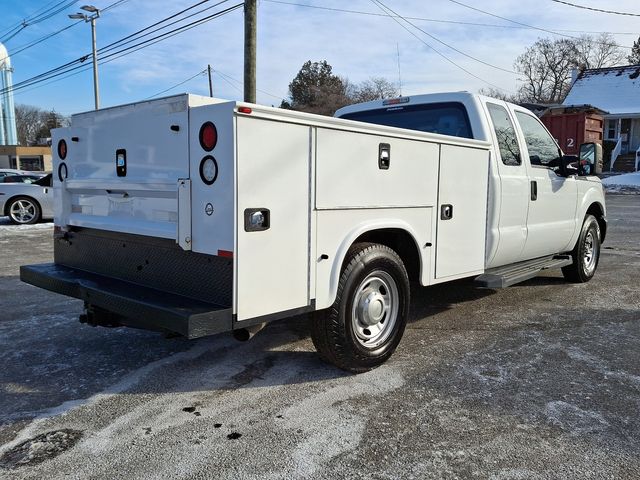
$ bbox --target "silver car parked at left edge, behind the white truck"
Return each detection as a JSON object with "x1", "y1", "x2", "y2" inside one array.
[{"x1": 0, "y1": 174, "x2": 53, "y2": 225}]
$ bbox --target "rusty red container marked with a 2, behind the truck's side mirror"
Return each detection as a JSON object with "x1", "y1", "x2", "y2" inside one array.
[{"x1": 540, "y1": 105, "x2": 606, "y2": 155}]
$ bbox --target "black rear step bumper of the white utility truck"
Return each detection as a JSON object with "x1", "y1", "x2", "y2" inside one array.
[{"x1": 20, "y1": 263, "x2": 233, "y2": 338}]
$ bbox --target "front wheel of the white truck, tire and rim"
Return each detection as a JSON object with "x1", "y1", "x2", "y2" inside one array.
[{"x1": 562, "y1": 215, "x2": 600, "y2": 283}]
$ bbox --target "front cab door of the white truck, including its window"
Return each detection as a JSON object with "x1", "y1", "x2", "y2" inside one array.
[{"x1": 514, "y1": 109, "x2": 578, "y2": 260}]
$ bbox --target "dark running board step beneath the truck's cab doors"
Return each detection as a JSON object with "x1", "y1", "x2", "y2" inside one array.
[{"x1": 474, "y1": 255, "x2": 573, "y2": 288}]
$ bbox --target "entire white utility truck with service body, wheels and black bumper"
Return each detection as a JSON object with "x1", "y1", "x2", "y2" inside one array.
[{"x1": 21, "y1": 93, "x2": 607, "y2": 372}]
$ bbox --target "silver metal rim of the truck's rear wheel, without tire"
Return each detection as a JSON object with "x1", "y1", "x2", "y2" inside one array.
[{"x1": 351, "y1": 271, "x2": 400, "y2": 348}]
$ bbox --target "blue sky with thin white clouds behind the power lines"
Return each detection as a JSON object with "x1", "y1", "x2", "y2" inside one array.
[{"x1": 0, "y1": 0, "x2": 640, "y2": 114}]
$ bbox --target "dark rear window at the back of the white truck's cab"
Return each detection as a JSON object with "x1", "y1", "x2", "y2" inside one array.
[{"x1": 340, "y1": 102, "x2": 473, "y2": 138}]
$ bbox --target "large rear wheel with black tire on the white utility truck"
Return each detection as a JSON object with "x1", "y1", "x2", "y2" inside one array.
[{"x1": 311, "y1": 243, "x2": 409, "y2": 373}]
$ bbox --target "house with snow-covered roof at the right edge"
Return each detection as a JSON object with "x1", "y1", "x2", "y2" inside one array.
[{"x1": 564, "y1": 65, "x2": 640, "y2": 171}]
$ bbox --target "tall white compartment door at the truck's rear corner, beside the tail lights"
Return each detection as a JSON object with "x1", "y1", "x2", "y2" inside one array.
[{"x1": 235, "y1": 116, "x2": 312, "y2": 321}]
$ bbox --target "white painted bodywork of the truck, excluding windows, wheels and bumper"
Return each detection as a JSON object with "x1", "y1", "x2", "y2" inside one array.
[{"x1": 45, "y1": 93, "x2": 604, "y2": 330}]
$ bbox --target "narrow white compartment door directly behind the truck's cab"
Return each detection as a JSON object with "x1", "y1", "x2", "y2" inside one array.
[{"x1": 435, "y1": 145, "x2": 489, "y2": 281}]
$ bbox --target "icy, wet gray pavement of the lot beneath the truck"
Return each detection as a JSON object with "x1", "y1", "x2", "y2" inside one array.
[{"x1": 0, "y1": 196, "x2": 640, "y2": 479}]
